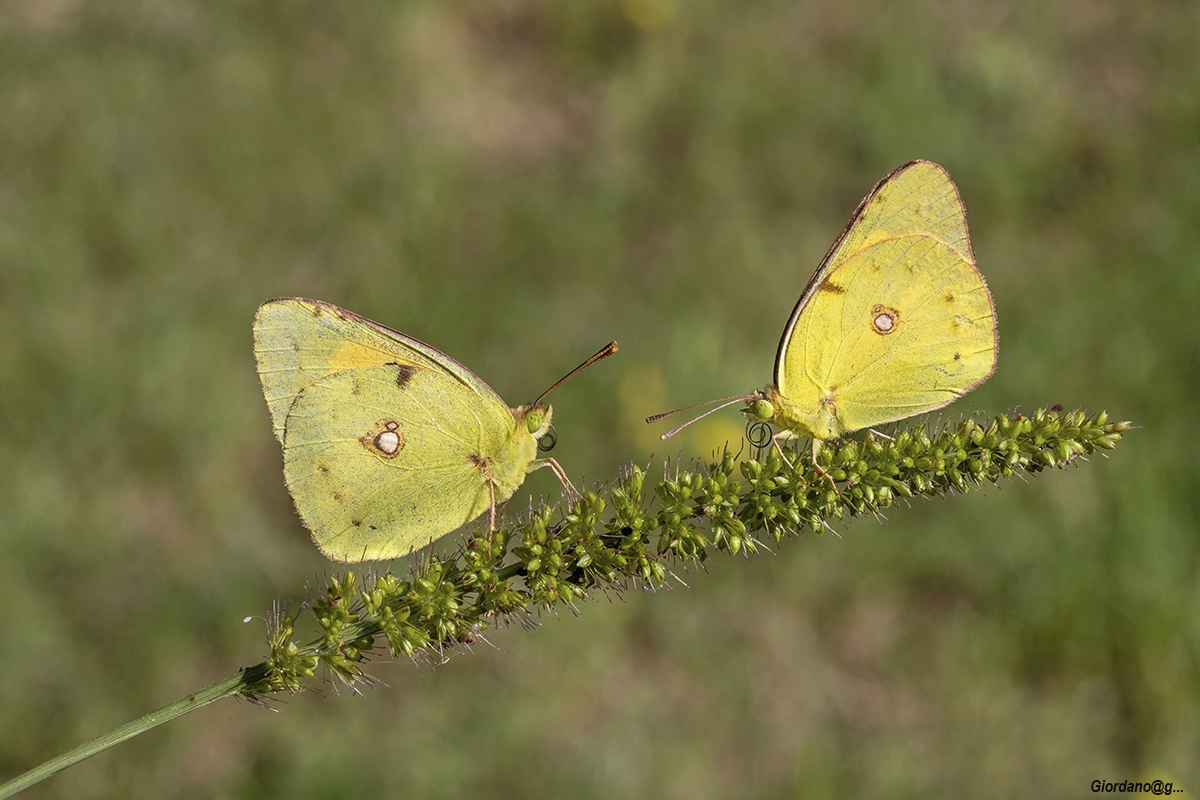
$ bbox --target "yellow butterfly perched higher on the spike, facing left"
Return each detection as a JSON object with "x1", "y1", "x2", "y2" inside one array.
[{"x1": 647, "y1": 161, "x2": 1000, "y2": 477}]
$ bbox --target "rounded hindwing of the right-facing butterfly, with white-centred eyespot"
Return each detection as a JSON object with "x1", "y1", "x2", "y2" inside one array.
[{"x1": 283, "y1": 365, "x2": 523, "y2": 561}]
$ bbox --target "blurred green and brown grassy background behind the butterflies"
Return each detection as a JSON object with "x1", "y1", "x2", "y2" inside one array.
[{"x1": 0, "y1": 0, "x2": 1200, "y2": 798}]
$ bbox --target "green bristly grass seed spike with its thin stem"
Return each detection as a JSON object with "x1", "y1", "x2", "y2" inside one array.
[{"x1": 0, "y1": 407, "x2": 1132, "y2": 800}]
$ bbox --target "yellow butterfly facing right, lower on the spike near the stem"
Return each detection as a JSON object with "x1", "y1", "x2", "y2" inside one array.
[{"x1": 254, "y1": 297, "x2": 617, "y2": 561}]
